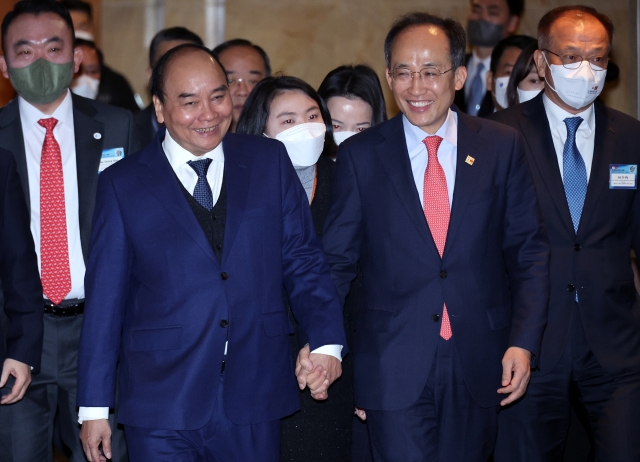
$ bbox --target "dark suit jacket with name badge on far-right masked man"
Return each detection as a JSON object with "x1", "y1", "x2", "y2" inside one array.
[{"x1": 492, "y1": 93, "x2": 640, "y2": 374}]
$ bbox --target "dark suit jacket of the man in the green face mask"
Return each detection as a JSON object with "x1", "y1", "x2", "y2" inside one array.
[{"x1": 0, "y1": 93, "x2": 140, "y2": 262}]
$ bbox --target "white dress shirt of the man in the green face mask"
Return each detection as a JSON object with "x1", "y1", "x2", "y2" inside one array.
[{"x1": 18, "y1": 90, "x2": 85, "y2": 299}]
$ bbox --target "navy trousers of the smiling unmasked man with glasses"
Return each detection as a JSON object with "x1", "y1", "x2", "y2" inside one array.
[{"x1": 366, "y1": 333, "x2": 500, "y2": 462}]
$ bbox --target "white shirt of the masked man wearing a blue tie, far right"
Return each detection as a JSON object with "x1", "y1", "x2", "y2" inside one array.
[{"x1": 542, "y1": 94, "x2": 596, "y2": 182}]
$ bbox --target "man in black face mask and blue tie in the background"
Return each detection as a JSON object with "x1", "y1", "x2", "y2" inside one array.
[{"x1": 454, "y1": 0, "x2": 524, "y2": 115}]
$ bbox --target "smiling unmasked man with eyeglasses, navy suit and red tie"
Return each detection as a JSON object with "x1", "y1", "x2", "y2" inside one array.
[{"x1": 323, "y1": 13, "x2": 549, "y2": 462}]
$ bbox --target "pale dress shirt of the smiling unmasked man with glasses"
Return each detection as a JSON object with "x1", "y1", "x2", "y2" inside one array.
[{"x1": 402, "y1": 109, "x2": 458, "y2": 206}]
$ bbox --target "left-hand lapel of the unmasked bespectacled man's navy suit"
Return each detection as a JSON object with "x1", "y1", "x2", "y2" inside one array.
[{"x1": 376, "y1": 114, "x2": 439, "y2": 255}]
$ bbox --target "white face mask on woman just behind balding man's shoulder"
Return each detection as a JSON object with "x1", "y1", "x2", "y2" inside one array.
[{"x1": 265, "y1": 123, "x2": 327, "y2": 167}]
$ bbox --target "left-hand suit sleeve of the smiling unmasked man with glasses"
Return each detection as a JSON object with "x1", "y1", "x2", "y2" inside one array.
[{"x1": 322, "y1": 144, "x2": 363, "y2": 305}]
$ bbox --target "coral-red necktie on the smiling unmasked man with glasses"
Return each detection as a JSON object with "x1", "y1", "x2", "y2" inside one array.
[{"x1": 422, "y1": 136, "x2": 452, "y2": 340}]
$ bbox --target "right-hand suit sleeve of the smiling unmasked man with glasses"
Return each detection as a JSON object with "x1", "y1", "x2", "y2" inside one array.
[{"x1": 503, "y1": 133, "x2": 550, "y2": 356}]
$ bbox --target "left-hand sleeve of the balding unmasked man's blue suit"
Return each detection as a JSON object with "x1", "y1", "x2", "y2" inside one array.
[{"x1": 77, "y1": 171, "x2": 132, "y2": 407}]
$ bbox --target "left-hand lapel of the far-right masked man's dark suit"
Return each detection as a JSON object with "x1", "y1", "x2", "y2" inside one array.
[{"x1": 519, "y1": 93, "x2": 574, "y2": 233}]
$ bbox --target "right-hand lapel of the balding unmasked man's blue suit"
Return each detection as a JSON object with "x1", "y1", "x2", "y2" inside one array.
[{"x1": 222, "y1": 133, "x2": 252, "y2": 263}]
